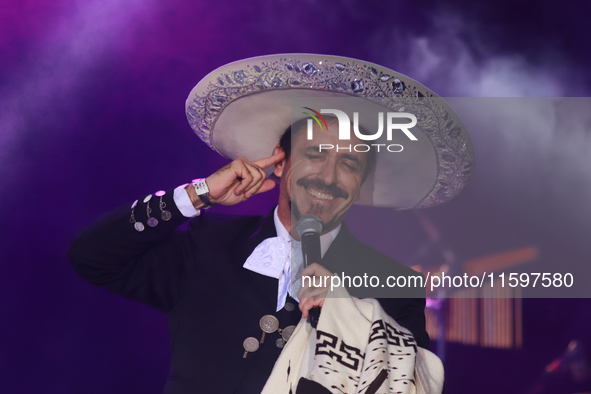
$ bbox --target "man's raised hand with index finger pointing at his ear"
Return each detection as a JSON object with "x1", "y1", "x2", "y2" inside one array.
[{"x1": 185, "y1": 152, "x2": 285, "y2": 209}]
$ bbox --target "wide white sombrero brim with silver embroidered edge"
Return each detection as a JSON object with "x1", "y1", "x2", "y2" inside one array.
[{"x1": 186, "y1": 54, "x2": 474, "y2": 209}]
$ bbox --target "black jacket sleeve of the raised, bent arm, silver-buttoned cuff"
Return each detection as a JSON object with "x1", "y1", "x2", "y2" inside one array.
[{"x1": 68, "y1": 191, "x2": 195, "y2": 312}]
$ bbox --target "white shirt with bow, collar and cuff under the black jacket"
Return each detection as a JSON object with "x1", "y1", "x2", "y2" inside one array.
[{"x1": 174, "y1": 184, "x2": 341, "y2": 311}]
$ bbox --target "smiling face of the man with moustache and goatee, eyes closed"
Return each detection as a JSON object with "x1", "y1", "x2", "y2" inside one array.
[{"x1": 275, "y1": 120, "x2": 367, "y2": 233}]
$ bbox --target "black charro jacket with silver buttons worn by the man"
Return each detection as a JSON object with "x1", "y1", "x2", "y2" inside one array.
[{"x1": 68, "y1": 191, "x2": 429, "y2": 394}]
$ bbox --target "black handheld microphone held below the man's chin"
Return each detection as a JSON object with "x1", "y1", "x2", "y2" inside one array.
[{"x1": 296, "y1": 214, "x2": 322, "y2": 328}]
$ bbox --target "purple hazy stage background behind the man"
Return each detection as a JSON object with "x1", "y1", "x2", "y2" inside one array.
[{"x1": 0, "y1": 0, "x2": 591, "y2": 394}]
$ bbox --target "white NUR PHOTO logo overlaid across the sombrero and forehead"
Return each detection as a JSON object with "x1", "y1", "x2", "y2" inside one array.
[{"x1": 302, "y1": 107, "x2": 417, "y2": 152}]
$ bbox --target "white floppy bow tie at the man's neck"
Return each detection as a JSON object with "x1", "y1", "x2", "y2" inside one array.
[{"x1": 244, "y1": 237, "x2": 303, "y2": 311}]
